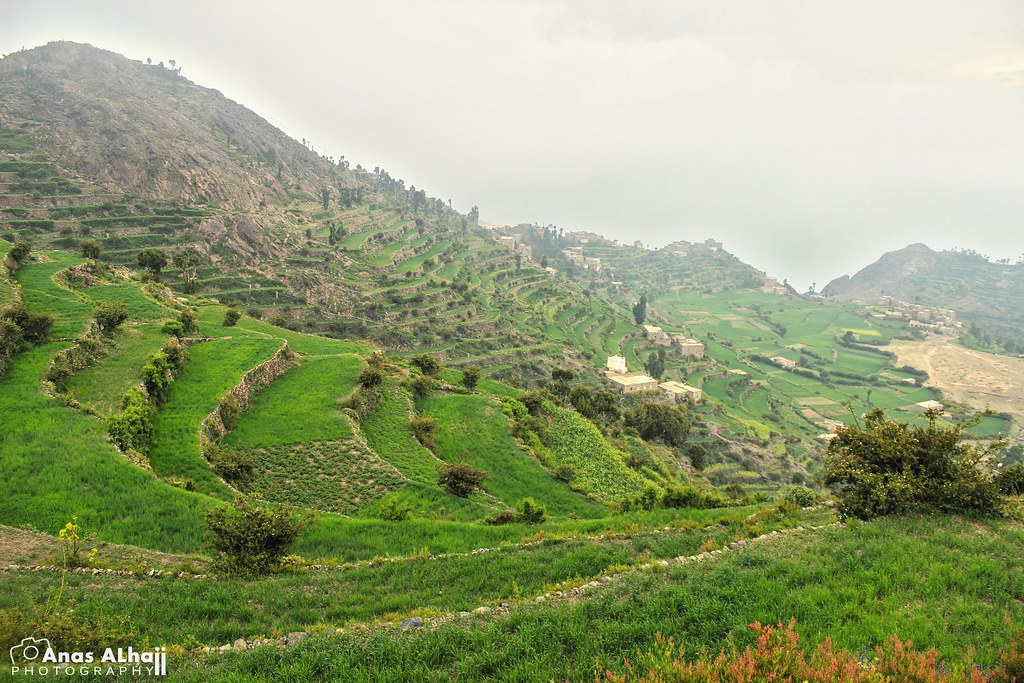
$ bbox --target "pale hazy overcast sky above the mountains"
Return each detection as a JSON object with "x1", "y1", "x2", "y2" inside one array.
[{"x1": 0, "y1": 0, "x2": 1024, "y2": 288}]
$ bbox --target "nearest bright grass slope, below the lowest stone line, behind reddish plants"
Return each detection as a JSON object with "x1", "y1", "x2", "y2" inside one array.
[{"x1": 165, "y1": 516, "x2": 1024, "y2": 681}]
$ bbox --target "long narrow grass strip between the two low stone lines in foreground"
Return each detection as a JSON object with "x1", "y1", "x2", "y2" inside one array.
[{"x1": 0, "y1": 505, "x2": 812, "y2": 644}]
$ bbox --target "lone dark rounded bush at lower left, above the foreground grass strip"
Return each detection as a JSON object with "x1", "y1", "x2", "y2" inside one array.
[{"x1": 206, "y1": 497, "x2": 301, "y2": 575}]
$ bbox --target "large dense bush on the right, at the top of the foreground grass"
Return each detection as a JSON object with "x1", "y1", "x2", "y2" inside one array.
[{"x1": 825, "y1": 409, "x2": 1004, "y2": 519}]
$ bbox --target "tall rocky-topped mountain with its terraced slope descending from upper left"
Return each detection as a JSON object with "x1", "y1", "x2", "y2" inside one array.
[{"x1": 0, "y1": 43, "x2": 647, "y2": 376}]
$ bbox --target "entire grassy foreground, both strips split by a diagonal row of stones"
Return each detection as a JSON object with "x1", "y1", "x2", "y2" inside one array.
[{"x1": 0, "y1": 513, "x2": 1024, "y2": 681}]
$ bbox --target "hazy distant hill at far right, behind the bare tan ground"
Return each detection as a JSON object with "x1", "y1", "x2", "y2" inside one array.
[{"x1": 821, "y1": 244, "x2": 1024, "y2": 352}]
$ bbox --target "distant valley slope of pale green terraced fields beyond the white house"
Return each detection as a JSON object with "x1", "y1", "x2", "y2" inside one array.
[{"x1": 511, "y1": 226, "x2": 1019, "y2": 486}]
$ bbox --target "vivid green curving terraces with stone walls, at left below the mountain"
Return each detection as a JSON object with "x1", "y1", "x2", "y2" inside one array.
[{"x1": 0, "y1": 251, "x2": 737, "y2": 560}]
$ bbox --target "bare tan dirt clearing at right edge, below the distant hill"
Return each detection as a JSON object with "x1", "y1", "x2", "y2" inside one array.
[{"x1": 888, "y1": 336, "x2": 1024, "y2": 430}]
